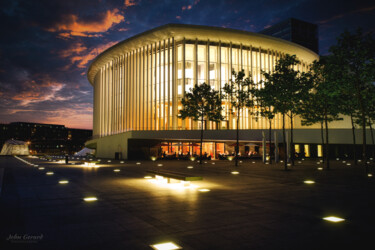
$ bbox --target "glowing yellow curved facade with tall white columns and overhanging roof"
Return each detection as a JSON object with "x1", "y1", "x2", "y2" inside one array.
[{"x1": 86, "y1": 24, "x2": 368, "y2": 158}]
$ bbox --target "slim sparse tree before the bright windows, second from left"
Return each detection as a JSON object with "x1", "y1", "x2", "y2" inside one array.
[{"x1": 223, "y1": 70, "x2": 253, "y2": 166}]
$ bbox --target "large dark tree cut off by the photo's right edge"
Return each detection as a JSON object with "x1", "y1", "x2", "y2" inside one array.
[{"x1": 329, "y1": 29, "x2": 375, "y2": 172}]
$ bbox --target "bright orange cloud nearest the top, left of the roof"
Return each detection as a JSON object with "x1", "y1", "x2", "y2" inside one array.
[{"x1": 47, "y1": 9, "x2": 124, "y2": 38}]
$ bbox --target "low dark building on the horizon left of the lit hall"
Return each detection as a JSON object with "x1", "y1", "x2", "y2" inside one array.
[{"x1": 0, "y1": 122, "x2": 92, "y2": 154}]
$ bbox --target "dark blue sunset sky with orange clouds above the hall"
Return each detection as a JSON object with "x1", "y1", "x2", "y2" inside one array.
[{"x1": 0, "y1": 0, "x2": 375, "y2": 129}]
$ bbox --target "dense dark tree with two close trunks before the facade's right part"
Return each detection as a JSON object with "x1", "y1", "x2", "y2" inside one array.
[{"x1": 263, "y1": 54, "x2": 310, "y2": 170}]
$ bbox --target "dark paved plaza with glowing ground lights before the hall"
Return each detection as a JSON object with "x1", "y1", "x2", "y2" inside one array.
[{"x1": 0, "y1": 157, "x2": 375, "y2": 249}]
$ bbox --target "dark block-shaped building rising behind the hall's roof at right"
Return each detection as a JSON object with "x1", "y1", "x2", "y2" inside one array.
[{"x1": 259, "y1": 18, "x2": 319, "y2": 54}]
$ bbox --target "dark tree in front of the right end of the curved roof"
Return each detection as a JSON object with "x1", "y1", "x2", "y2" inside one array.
[{"x1": 298, "y1": 57, "x2": 342, "y2": 169}]
